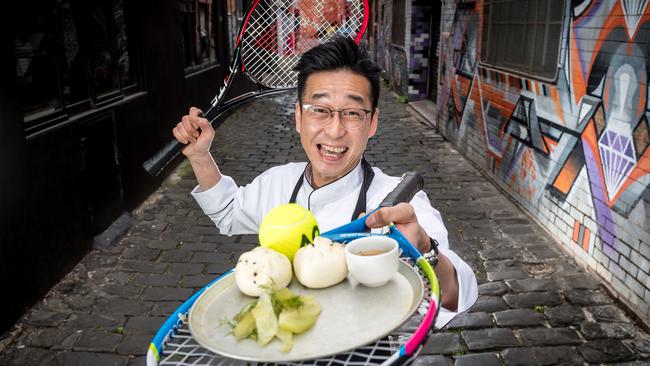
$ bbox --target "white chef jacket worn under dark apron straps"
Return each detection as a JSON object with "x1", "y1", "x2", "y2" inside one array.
[{"x1": 192, "y1": 162, "x2": 478, "y2": 328}]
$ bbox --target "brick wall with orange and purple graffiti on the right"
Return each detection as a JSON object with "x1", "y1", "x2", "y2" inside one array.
[{"x1": 437, "y1": 0, "x2": 650, "y2": 320}]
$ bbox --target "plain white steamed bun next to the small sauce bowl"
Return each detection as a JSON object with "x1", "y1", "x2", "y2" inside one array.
[{"x1": 293, "y1": 236, "x2": 348, "y2": 288}]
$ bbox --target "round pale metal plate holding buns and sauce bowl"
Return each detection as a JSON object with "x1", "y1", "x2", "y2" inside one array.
[{"x1": 189, "y1": 261, "x2": 424, "y2": 362}]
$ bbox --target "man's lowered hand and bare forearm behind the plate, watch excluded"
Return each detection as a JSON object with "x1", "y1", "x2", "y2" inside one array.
[{"x1": 366, "y1": 203, "x2": 458, "y2": 311}]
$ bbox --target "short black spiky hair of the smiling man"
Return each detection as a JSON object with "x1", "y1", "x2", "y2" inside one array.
[{"x1": 293, "y1": 36, "x2": 381, "y2": 109}]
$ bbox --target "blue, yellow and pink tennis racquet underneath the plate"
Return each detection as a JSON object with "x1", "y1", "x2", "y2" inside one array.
[{"x1": 147, "y1": 173, "x2": 440, "y2": 366}]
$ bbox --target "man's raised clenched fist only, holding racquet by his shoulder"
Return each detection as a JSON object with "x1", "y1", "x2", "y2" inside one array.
[{"x1": 172, "y1": 107, "x2": 214, "y2": 159}]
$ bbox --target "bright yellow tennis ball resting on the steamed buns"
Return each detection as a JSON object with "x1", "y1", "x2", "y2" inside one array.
[{"x1": 259, "y1": 203, "x2": 320, "y2": 261}]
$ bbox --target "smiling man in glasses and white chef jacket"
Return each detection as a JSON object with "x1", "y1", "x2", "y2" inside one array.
[{"x1": 173, "y1": 38, "x2": 478, "y2": 327}]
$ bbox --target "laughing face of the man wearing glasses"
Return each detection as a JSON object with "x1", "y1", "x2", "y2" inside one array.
[{"x1": 296, "y1": 70, "x2": 379, "y2": 187}]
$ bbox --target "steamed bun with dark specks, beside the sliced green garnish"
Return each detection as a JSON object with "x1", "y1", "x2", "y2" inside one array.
[{"x1": 235, "y1": 247, "x2": 292, "y2": 297}]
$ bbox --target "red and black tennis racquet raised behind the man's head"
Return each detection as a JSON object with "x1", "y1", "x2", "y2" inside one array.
[{"x1": 143, "y1": 0, "x2": 369, "y2": 176}]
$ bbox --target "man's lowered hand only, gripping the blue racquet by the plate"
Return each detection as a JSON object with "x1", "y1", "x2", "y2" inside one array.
[{"x1": 366, "y1": 202, "x2": 431, "y2": 253}]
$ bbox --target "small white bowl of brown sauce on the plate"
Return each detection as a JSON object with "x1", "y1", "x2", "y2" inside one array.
[{"x1": 345, "y1": 236, "x2": 399, "y2": 287}]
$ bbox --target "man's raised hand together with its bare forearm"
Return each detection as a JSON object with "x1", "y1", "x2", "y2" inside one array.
[{"x1": 172, "y1": 107, "x2": 221, "y2": 191}]
